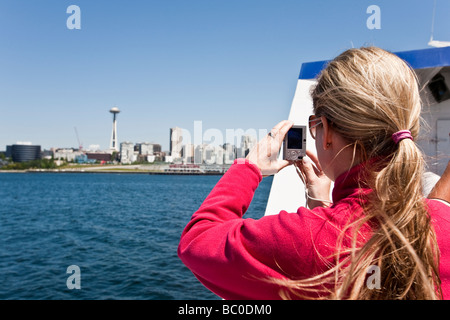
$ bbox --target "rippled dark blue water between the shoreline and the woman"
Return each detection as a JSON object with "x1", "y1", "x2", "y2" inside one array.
[{"x1": 0, "y1": 173, "x2": 272, "y2": 300}]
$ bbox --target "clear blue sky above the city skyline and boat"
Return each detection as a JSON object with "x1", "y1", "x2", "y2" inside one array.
[{"x1": 0, "y1": 0, "x2": 450, "y2": 150}]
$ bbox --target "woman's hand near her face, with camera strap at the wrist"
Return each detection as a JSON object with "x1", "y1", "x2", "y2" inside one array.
[{"x1": 295, "y1": 150, "x2": 332, "y2": 209}]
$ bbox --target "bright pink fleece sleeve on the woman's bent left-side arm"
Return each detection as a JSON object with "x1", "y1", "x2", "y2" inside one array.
[{"x1": 178, "y1": 161, "x2": 332, "y2": 300}]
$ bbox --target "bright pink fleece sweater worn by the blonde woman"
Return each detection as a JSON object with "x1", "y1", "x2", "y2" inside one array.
[{"x1": 178, "y1": 161, "x2": 450, "y2": 300}]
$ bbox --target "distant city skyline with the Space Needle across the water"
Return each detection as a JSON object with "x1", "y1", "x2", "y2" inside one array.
[{"x1": 2, "y1": 125, "x2": 258, "y2": 165}]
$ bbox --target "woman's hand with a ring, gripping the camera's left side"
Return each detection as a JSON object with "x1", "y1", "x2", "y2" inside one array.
[{"x1": 246, "y1": 120, "x2": 294, "y2": 177}]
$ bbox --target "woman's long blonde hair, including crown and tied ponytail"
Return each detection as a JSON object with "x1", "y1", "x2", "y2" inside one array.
[{"x1": 278, "y1": 47, "x2": 441, "y2": 299}]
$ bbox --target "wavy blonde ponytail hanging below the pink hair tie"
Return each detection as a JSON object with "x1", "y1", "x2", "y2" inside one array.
[{"x1": 356, "y1": 139, "x2": 442, "y2": 300}]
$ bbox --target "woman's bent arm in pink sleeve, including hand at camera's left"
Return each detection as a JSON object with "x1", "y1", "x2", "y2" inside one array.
[{"x1": 178, "y1": 121, "x2": 296, "y2": 299}]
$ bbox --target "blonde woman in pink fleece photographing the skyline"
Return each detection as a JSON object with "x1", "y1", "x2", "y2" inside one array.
[{"x1": 178, "y1": 47, "x2": 450, "y2": 299}]
